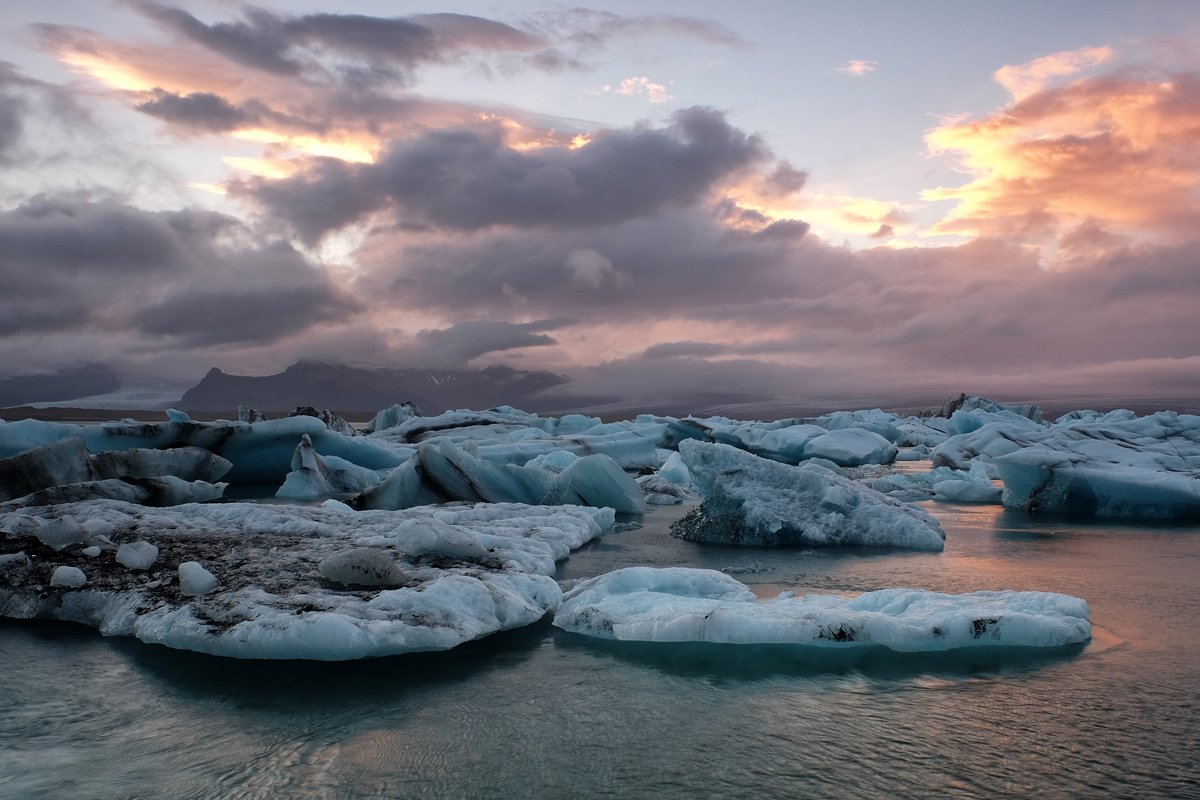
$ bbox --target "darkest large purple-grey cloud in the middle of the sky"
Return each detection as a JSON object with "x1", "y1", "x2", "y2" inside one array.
[{"x1": 241, "y1": 108, "x2": 770, "y2": 241}]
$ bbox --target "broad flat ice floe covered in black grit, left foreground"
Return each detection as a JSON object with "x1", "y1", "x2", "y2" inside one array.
[{"x1": 0, "y1": 501, "x2": 613, "y2": 661}]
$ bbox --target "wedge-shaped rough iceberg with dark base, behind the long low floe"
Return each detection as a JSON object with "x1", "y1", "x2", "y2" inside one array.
[{"x1": 671, "y1": 441, "x2": 946, "y2": 551}]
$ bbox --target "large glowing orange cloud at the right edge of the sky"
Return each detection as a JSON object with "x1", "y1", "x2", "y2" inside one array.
[{"x1": 923, "y1": 48, "x2": 1200, "y2": 252}]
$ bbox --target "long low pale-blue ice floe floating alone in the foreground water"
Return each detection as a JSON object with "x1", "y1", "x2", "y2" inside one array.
[{"x1": 554, "y1": 567, "x2": 1092, "y2": 652}]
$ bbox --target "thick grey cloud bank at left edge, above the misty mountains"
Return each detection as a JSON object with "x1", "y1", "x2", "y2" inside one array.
[{"x1": 0, "y1": 199, "x2": 360, "y2": 345}]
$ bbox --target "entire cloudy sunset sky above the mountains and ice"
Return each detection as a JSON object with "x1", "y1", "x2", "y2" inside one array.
[{"x1": 0, "y1": 0, "x2": 1200, "y2": 402}]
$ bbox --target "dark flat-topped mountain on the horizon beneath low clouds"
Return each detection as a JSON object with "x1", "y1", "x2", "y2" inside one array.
[{"x1": 179, "y1": 361, "x2": 568, "y2": 414}]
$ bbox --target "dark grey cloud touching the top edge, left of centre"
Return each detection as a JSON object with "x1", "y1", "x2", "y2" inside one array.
[{"x1": 134, "y1": 0, "x2": 554, "y2": 86}]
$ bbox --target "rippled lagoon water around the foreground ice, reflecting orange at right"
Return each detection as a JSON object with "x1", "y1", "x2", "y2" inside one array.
[{"x1": 0, "y1": 505, "x2": 1200, "y2": 800}]
